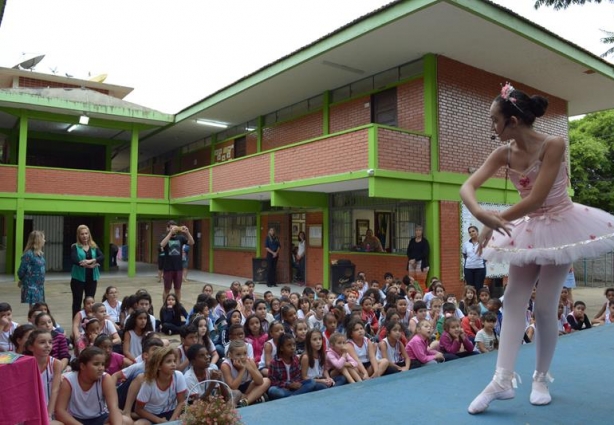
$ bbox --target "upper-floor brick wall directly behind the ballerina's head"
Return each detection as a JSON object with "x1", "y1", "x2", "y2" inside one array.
[{"x1": 437, "y1": 56, "x2": 568, "y2": 177}]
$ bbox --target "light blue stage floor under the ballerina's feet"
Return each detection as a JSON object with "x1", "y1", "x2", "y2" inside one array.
[{"x1": 239, "y1": 325, "x2": 614, "y2": 425}]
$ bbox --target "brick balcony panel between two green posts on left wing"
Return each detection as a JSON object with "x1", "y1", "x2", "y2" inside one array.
[{"x1": 26, "y1": 167, "x2": 130, "y2": 198}]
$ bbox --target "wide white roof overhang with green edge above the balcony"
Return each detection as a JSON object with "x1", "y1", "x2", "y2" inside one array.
[{"x1": 143, "y1": 0, "x2": 614, "y2": 160}]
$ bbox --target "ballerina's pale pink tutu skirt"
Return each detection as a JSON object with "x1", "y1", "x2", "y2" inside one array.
[{"x1": 483, "y1": 203, "x2": 614, "y2": 266}]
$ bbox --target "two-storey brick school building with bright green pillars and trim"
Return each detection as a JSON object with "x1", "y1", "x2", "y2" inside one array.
[{"x1": 0, "y1": 0, "x2": 614, "y2": 293}]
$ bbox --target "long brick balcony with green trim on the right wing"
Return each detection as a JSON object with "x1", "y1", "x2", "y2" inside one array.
[{"x1": 170, "y1": 124, "x2": 430, "y2": 202}]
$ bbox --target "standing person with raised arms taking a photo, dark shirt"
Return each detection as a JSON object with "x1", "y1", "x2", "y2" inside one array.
[{"x1": 160, "y1": 220, "x2": 194, "y2": 304}]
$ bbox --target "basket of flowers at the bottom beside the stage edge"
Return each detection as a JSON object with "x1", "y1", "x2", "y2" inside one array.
[{"x1": 182, "y1": 395, "x2": 243, "y2": 425}]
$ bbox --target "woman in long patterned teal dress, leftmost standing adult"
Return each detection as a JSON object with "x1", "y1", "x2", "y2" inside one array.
[{"x1": 17, "y1": 230, "x2": 45, "y2": 307}]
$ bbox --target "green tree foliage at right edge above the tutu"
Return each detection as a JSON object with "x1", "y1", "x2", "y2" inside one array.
[{"x1": 569, "y1": 110, "x2": 614, "y2": 211}]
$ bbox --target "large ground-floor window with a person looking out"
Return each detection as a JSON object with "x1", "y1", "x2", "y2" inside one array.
[{"x1": 330, "y1": 191, "x2": 425, "y2": 253}]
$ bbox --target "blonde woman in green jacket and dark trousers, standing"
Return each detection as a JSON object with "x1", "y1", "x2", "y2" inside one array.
[{"x1": 70, "y1": 224, "x2": 104, "y2": 317}]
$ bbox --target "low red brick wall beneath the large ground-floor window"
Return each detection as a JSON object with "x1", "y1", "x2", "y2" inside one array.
[{"x1": 327, "y1": 252, "x2": 407, "y2": 283}]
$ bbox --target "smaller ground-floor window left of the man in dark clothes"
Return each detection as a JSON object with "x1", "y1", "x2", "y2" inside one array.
[{"x1": 213, "y1": 214, "x2": 258, "y2": 249}]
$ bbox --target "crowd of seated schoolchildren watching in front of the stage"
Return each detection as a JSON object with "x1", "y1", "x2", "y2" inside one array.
[{"x1": 0, "y1": 273, "x2": 614, "y2": 425}]
